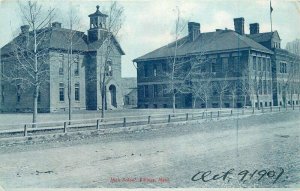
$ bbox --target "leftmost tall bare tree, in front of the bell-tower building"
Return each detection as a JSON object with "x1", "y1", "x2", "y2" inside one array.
[{"x1": 4, "y1": 1, "x2": 54, "y2": 123}]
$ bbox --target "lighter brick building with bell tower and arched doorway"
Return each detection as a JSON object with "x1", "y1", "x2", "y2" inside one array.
[{"x1": 0, "y1": 6, "x2": 134, "y2": 112}]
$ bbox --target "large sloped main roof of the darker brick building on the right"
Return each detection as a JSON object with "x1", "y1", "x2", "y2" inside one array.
[{"x1": 133, "y1": 30, "x2": 273, "y2": 62}]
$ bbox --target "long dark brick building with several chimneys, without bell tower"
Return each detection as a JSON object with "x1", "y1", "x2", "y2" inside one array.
[{"x1": 134, "y1": 18, "x2": 299, "y2": 108}]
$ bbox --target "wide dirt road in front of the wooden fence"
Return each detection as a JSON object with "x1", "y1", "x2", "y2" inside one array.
[{"x1": 0, "y1": 111, "x2": 300, "y2": 188}]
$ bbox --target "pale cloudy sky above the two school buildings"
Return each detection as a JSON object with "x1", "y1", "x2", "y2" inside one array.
[{"x1": 0, "y1": 0, "x2": 300, "y2": 77}]
